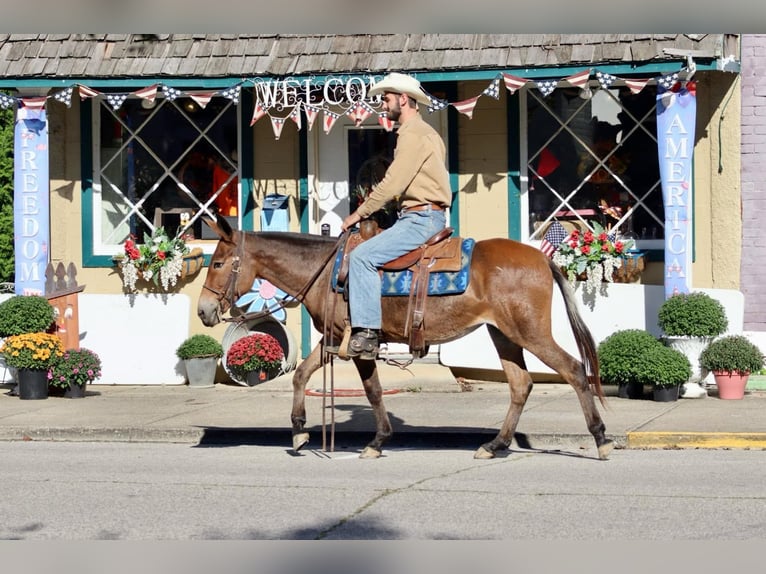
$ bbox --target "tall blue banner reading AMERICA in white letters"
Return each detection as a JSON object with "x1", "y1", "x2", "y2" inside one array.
[{"x1": 657, "y1": 82, "x2": 697, "y2": 299}]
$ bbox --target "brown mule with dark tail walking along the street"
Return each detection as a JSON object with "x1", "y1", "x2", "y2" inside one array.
[{"x1": 197, "y1": 218, "x2": 614, "y2": 460}]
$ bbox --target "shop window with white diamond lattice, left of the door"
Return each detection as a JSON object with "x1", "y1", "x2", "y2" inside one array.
[{"x1": 93, "y1": 98, "x2": 240, "y2": 255}]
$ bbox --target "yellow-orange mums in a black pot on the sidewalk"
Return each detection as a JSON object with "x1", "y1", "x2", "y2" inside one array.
[{"x1": 0, "y1": 333, "x2": 64, "y2": 399}]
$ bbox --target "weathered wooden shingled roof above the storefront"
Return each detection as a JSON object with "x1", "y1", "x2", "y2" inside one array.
[{"x1": 0, "y1": 34, "x2": 738, "y2": 80}]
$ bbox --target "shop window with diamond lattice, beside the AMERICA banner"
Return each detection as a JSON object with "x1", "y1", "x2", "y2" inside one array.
[{"x1": 526, "y1": 86, "x2": 664, "y2": 248}]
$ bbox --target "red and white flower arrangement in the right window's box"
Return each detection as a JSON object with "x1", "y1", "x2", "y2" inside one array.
[{"x1": 553, "y1": 222, "x2": 633, "y2": 295}]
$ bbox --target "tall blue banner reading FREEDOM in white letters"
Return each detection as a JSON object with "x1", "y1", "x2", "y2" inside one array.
[{"x1": 13, "y1": 107, "x2": 50, "y2": 295}]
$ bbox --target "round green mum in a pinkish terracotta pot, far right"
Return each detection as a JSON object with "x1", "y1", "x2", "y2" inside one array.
[{"x1": 700, "y1": 335, "x2": 764, "y2": 399}]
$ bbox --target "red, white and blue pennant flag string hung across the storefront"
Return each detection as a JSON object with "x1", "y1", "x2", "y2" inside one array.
[{"x1": 0, "y1": 68, "x2": 682, "y2": 139}]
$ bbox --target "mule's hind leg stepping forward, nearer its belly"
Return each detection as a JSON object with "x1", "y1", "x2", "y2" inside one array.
[{"x1": 480, "y1": 325, "x2": 532, "y2": 458}]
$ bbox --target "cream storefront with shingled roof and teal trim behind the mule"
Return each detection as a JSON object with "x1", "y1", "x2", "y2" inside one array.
[{"x1": 0, "y1": 35, "x2": 742, "y2": 383}]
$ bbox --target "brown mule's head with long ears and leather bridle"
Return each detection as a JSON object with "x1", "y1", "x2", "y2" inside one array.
[{"x1": 197, "y1": 217, "x2": 254, "y2": 327}]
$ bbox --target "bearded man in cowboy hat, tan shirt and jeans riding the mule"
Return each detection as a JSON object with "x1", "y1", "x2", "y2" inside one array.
[{"x1": 342, "y1": 72, "x2": 452, "y2": 360}]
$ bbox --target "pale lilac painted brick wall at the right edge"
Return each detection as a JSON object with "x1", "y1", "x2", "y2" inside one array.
[{"x1": 740, "y1": 34, "x2": 766, "y2": 331}]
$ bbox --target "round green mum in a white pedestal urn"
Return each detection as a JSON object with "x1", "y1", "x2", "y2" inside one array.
[{"x1": 657, "y1": 291, "x2": 729, "y2": 398}]
